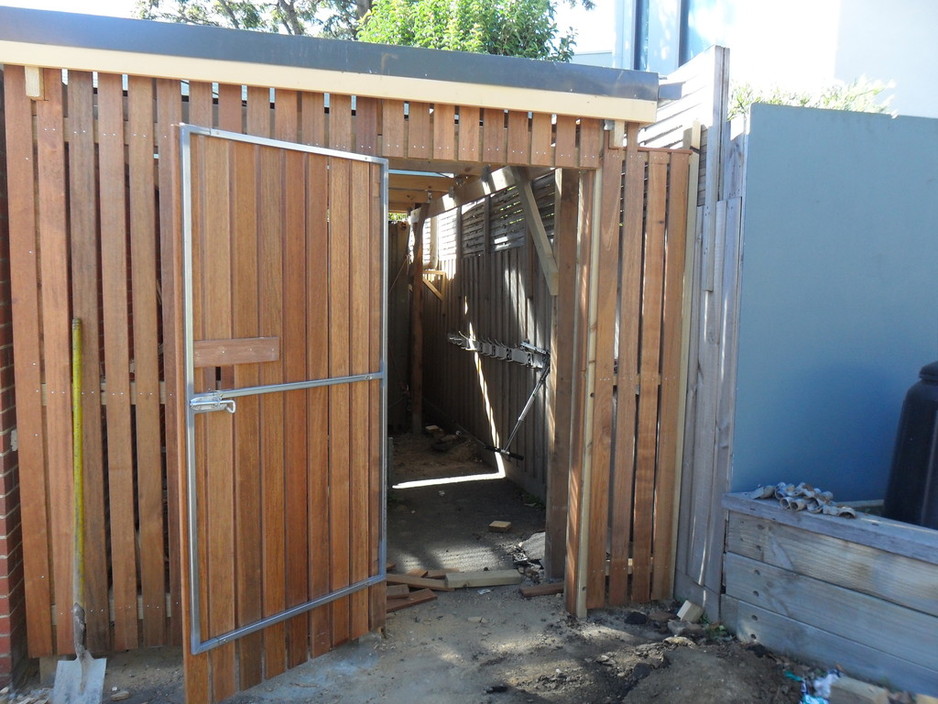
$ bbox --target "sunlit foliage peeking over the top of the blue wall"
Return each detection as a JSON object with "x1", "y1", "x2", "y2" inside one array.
[{"x1": 729, "y1": 78, "x2": 890, "y2": 119}]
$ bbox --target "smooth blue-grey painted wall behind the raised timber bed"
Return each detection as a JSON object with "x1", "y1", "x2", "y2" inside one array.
[{"x1": 731, "y1": 105, "x2": 938, "y2": 501}]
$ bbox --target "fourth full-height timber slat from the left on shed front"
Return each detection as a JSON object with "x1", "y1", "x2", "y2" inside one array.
[{"x1": 98, "y1": 74, "x2": 139, "y2": 650}]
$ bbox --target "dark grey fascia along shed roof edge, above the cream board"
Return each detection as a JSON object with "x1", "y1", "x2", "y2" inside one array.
[{"x1": 0, "y1": 6, "x2": 658, "y2": 101}]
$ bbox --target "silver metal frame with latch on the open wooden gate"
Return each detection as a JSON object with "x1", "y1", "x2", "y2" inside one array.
[{"x1": 179, "y1": 124, "x2": 388, "y2": 655}]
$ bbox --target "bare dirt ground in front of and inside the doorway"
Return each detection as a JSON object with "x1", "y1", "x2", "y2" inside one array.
[{"x1": 7, "y1": 436, "x2": 836, "y2": 704}]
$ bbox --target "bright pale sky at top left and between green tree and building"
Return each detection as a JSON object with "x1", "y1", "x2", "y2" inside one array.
[{"x1": 0, "y1": 0, "x2": 614, "y2": 51}]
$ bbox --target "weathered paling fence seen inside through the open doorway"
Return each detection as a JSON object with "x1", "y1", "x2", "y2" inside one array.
[{"x1": 423, "y1": 174, "x2": 555, "y2": 499}]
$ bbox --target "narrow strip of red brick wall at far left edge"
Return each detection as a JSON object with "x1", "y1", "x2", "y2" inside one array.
[{"x1": 0, "y1": 72, "x2": 26, "y2": 686}]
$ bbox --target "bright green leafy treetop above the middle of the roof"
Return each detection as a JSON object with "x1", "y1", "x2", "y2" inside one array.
[{"x1": 358, "y1": 0, "x2": 576, "y2": 61}]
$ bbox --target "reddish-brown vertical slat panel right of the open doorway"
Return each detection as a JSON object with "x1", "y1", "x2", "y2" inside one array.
[{"x1": 566, "y1": 144, "x2": 690, "y2": 613}]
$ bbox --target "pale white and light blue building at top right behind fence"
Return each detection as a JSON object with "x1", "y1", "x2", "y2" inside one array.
[{"x1": 560, "y1": 0, "x2": 938, "y2": 117}]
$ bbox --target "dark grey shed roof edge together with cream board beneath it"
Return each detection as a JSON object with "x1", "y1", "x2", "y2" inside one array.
[{"x1": 0, "y1": 7, "x2": 658, "y2": 123}]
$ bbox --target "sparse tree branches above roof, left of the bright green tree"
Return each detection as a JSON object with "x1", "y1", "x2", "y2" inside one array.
[{"x1": 136, "y1": 0, "x2": 371, "y2": 39}]
